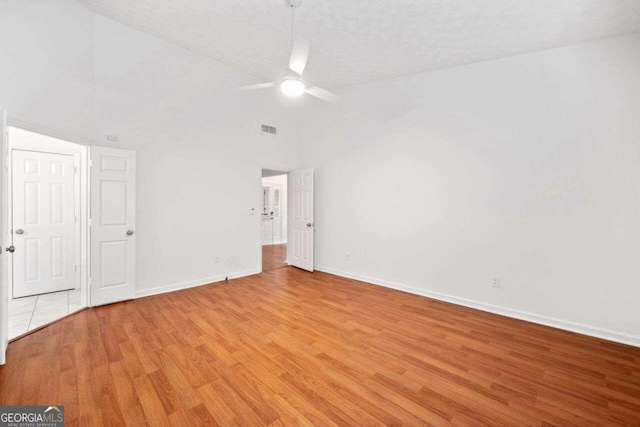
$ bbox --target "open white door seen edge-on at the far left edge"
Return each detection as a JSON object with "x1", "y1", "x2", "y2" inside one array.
[{"x1": 0, "y1": 110, "x2": 11, "y2": 365}]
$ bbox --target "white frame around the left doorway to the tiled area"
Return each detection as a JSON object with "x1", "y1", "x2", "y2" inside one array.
[{"x1": 5, "y1": 120, "x2": 91, "y2": 308}]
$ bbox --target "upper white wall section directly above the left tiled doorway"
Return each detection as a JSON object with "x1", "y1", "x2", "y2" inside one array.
[{"x1": 0, "y1": 0, "x2": 94, "y2": 141}]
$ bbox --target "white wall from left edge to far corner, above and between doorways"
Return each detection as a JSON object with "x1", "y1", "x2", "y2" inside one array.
[{"x1": 0, "y1": 0, "x2": 297, "y2": 294}]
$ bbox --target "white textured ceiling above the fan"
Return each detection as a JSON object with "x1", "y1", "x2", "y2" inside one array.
[{"x1": 80, "y1": 0, "x2": 640, "y2": 89}]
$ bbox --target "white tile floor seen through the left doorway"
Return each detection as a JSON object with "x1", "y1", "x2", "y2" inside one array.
[{"x1": 9, "y1": 289, "x2": 82, "y2": 339}]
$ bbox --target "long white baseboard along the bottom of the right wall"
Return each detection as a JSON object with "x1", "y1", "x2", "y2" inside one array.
[{"x1": 315, "y1": 266, "x2": 640, "y2": 347}]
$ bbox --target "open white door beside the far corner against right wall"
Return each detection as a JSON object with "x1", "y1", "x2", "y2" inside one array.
[{"x1": 287, "y1": 168, "x2": 314, "y2": 271}]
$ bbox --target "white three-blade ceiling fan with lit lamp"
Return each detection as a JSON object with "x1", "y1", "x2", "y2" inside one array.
[{"x1": 238, "y1": 0, "x2": 339, "y2": 103}]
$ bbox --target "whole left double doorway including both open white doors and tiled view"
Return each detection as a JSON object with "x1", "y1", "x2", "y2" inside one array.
[{"x1": 0, "y1": 119, "x2": 137, "y2": 358}]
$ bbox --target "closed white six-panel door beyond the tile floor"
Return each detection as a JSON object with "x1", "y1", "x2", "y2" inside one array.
[{"x1": 11, "y1": 150, "x2": 76, "y2": 298}]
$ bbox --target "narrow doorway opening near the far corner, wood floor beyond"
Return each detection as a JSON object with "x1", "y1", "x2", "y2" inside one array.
[{"x1": 260, "y1": 169, "x2": 287, "y2": 271}]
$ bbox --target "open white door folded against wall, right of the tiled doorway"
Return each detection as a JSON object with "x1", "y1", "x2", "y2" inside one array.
[{"x1": 90, "y1": 147, "x2": 136, "y2": 306}]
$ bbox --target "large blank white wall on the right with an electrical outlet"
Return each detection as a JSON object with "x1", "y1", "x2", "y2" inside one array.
[{"x1": 299, "y1": 35, "x2": 640, "y2": 345}]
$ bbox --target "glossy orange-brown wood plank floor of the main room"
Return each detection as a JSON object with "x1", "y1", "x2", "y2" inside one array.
[{"x1": 0, "y1": 267, "x2": 640, "y2": 426}]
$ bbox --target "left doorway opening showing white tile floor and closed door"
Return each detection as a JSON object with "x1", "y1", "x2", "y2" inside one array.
[{"x1": 7, "y1": 127, "x2": 87, "y2": 339}]
